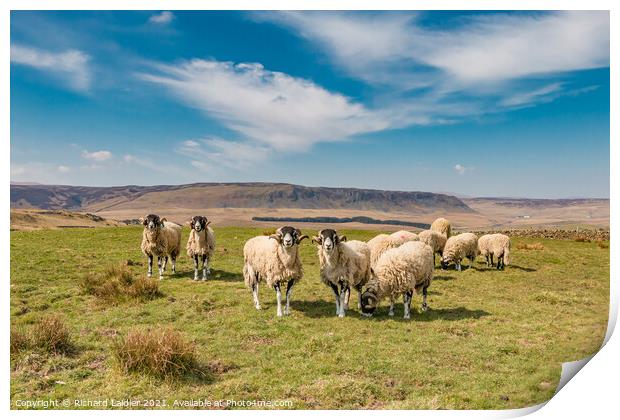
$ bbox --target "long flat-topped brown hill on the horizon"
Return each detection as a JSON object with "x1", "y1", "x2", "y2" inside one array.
[{"x1": 11, "y1": 183, "x2": 473, "y2": 213}]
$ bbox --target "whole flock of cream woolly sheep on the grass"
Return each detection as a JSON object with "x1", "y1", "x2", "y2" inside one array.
[{"x1": 140, "y1": 214, "x2": 510, "y2": 319}]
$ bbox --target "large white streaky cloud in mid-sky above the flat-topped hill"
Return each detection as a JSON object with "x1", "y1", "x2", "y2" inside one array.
[{"x1": 140, "y1": 60, "x2": 390, "y2": 151}]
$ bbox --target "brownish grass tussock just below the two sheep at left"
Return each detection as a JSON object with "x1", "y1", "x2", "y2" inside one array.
[{"x1": 80, "y1": 264, "x2": 162, "y2": 302}]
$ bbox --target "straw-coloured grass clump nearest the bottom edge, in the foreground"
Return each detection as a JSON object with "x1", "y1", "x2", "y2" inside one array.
[{"x1": 113, "y1": 328, "x2": 200, "y2": 377}]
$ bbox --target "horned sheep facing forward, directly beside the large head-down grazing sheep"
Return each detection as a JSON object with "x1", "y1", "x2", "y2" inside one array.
[{"x1": 312, "y1": 229, "x2": 370, "y2": 318}]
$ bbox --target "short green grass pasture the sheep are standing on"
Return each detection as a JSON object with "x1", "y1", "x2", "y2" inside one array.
[{"x1": 10, "y1": 227, "x2": 609, "y2": 409}]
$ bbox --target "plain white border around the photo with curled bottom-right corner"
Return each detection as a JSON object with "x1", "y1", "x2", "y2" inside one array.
[{"x1": 0, "y1": 0, "x2": 620, "y2": 419}]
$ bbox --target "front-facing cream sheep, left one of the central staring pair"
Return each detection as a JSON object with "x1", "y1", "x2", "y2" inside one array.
[{"x1": 243, "y1": 226, "x2": 308, "y2": 316}]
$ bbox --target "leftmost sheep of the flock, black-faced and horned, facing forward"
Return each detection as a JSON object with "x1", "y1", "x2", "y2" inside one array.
[{"x1": 140, "y1": 214, "x2": 181, "y2": 280}]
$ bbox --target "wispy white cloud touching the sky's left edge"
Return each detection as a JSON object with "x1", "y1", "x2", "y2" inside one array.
[{"x1": 11, "y1": 45, "x2": 91, "y2": 91}]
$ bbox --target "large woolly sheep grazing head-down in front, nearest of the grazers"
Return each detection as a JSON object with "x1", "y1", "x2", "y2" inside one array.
[{"x1": 362, "y1": 241, "x2": 435, "y2": 319}]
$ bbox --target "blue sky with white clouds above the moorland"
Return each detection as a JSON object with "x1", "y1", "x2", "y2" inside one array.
[{"x1": 10, "y1": 11, "x2": 610, "y2": 198}]
